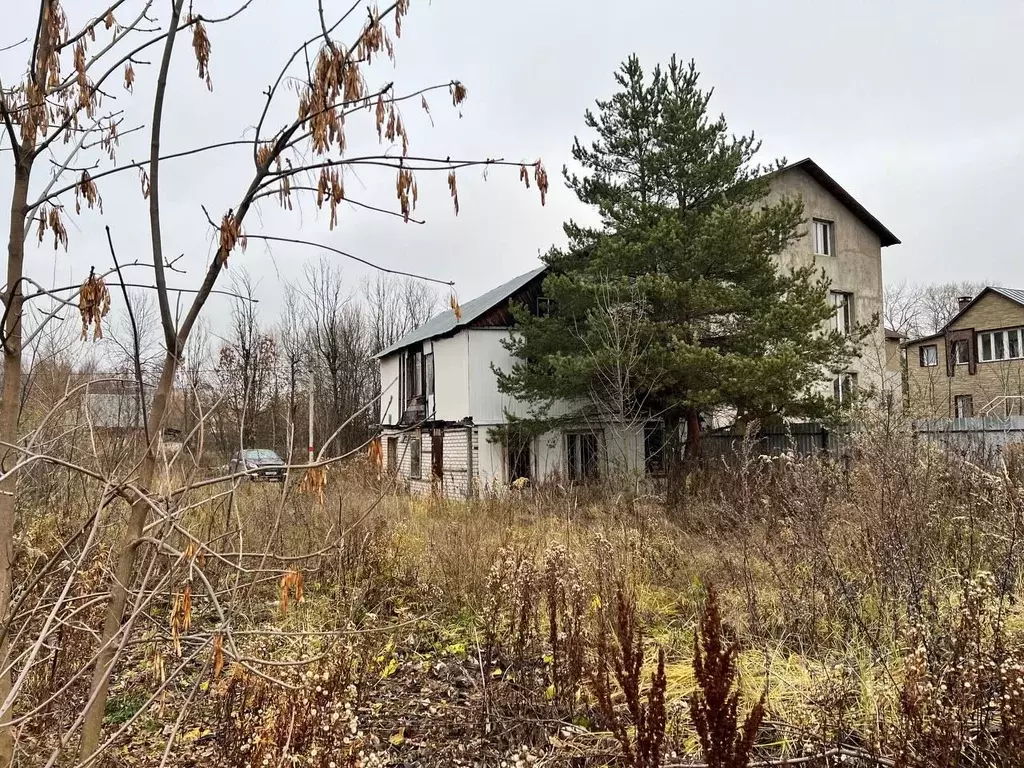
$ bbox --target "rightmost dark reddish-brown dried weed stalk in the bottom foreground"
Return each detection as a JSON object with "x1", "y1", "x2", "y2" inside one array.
[{"x1": 690, "y1": 589, "x2": 764, "y2": 768}]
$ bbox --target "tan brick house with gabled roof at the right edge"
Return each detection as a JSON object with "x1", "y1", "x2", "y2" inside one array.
[{"x1": 905, "y1": 287, "x2": 1024, "y2": 419}]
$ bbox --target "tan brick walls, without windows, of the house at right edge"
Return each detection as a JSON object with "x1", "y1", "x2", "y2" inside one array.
[{"x1": 906, "y1": 293, "x2": 1024, "y2": 418}]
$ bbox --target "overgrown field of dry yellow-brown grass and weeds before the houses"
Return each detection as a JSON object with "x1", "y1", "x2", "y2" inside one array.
[{"x1": 12, "y1": 427, "x2": 1024, "y2": 768}]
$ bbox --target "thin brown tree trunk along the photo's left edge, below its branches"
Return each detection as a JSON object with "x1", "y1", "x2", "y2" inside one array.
[{"x1": 0, "y1": 154, "x2": 34, "y2": 768}]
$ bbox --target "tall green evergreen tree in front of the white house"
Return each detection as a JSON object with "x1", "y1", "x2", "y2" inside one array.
[{"x1": 498, "y1": 56, "x2": 863, "y2": 499}]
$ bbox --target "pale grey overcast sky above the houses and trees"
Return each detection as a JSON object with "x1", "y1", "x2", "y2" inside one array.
[{"x1": 0, "y1": 0, "x2": 1024, "y2": 348}]
